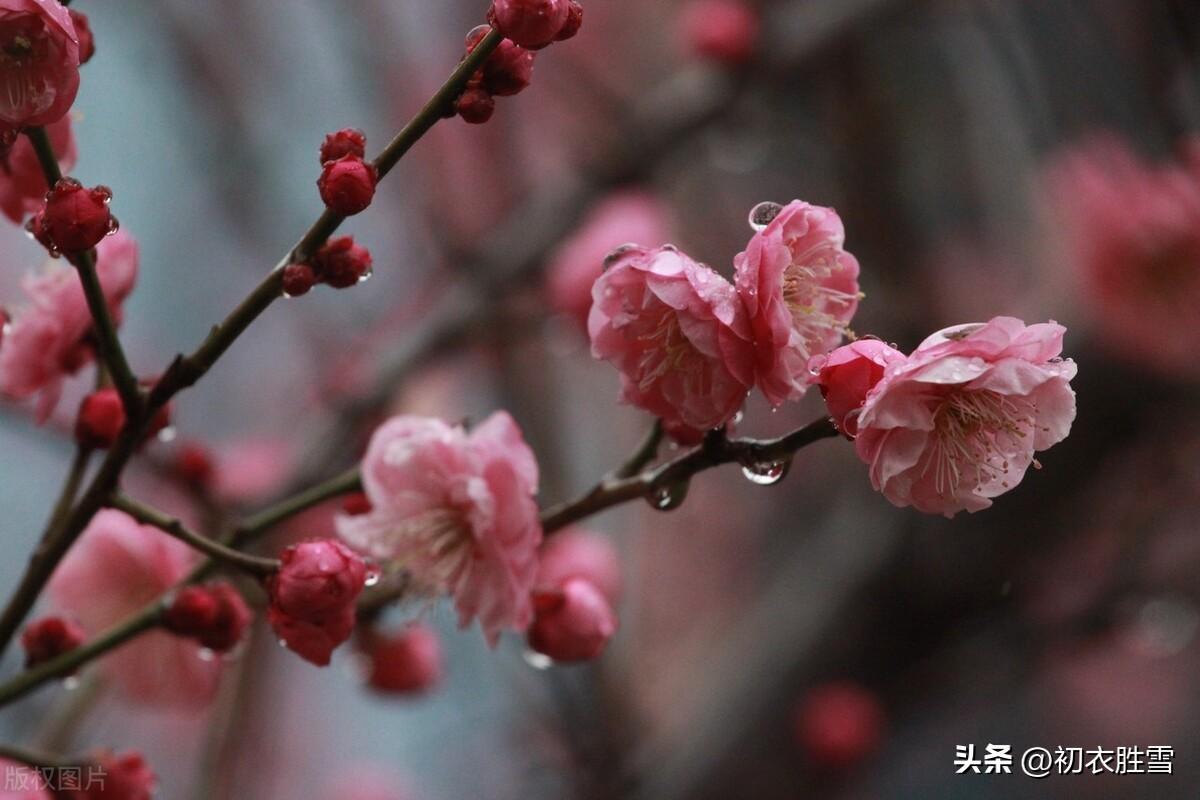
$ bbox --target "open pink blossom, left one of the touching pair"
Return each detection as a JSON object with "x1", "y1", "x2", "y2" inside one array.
[{"x1": 588, "y1": 245, "x2": 755, "y2": 441}]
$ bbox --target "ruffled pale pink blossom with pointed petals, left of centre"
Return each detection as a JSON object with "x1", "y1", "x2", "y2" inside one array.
[{"x1": 336, "y1": 411, "x2": 541, "y2": 645}]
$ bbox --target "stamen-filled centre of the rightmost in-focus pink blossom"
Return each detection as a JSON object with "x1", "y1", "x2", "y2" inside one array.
[{"x1": 925, "y1": 391, "x2": 1038, "y2": 494}]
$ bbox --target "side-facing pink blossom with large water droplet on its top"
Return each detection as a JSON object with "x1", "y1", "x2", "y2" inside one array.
[{"x1": 733, "y1": 200, "x2": 860, "y2": 405}]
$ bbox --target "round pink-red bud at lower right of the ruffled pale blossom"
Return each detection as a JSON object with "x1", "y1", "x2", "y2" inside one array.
[{"x1": 528, "y1": 578, "x2": 617, "y2": 661}]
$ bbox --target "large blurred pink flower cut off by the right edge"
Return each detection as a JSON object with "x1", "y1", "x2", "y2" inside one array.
[{"x1": 1050, "y1": 137, "x2": 1200, "y2": 379}]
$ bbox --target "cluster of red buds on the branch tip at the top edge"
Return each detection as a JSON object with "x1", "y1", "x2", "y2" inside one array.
[{"x1": 455, "y1": 0, "x2": 583, "y2": 125}]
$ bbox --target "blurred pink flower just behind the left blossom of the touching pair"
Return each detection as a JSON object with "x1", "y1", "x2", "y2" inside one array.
[{"x1": 546, "y1": 191, "x2": 671, "y2": 329}]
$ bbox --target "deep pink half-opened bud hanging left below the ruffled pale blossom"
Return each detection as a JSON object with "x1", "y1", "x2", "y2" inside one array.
[{"x1": 266, "y1": 539, "x2": 367, "y2": 667}]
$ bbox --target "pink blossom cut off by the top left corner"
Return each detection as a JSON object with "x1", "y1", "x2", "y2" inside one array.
[{"x1": 0, "y1": 0, "x2": 79, "y2": 128}]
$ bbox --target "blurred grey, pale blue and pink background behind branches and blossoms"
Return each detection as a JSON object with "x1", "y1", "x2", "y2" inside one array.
[{"x1": 0, "y1": 0, "x2": 1200, "y2": 800}]
